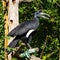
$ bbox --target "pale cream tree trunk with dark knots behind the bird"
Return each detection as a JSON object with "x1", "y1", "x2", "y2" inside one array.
[{"x1": 8, "y1": 0, "x2": 31, "y2": 60}]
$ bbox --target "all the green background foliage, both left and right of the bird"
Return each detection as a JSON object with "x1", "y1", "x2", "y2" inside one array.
[{"x1": 0, "y1": 0, "x2": 60, "y2": 60}]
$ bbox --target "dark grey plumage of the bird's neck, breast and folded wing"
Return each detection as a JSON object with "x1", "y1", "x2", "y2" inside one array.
[{"x1": 8, "y1": 18, "x2": 39, "y2": 36}]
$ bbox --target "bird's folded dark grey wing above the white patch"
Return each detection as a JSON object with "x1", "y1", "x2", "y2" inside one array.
[{"x1": 8, "y1": 21, "x2": 33, "y2": 36}]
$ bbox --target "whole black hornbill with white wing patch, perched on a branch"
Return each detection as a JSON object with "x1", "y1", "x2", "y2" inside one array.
[{"x1": 8, "y1": 10, "x2": 50, "y2": 48}]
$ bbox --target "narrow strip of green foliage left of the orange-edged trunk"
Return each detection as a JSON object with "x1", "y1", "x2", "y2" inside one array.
[{"x1": 0, "y1": 1, "x2": 4, "y2": 60}]
